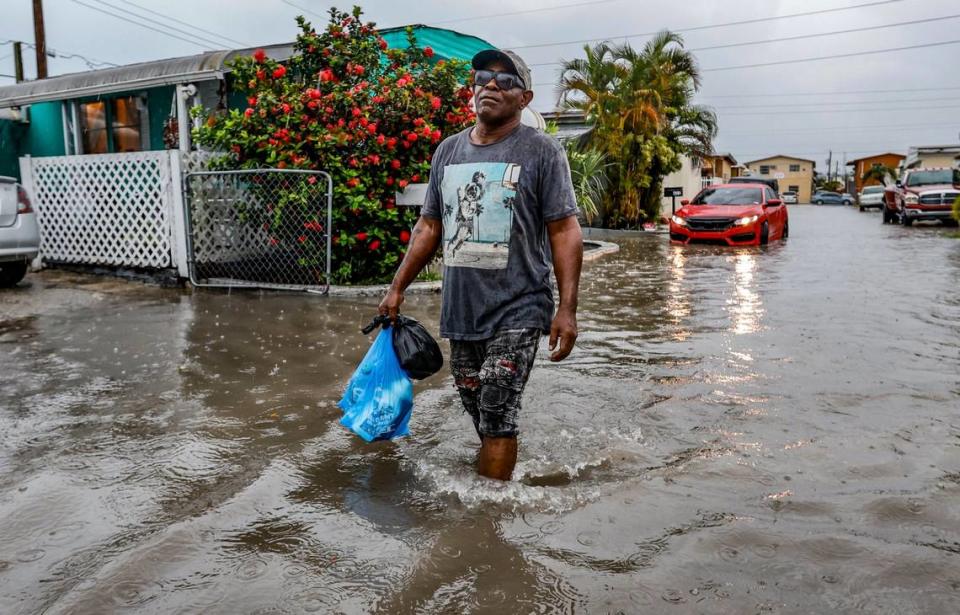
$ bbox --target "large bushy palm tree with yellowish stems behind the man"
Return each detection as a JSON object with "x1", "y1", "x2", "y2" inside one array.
[{"x1": 557, "y1": 31, "x2": 717, "y2": 226}]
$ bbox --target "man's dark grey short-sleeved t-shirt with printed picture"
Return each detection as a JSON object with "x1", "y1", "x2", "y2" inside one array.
[{"x1": 422, "y1": 125, "x2": 577, "y2": 340}]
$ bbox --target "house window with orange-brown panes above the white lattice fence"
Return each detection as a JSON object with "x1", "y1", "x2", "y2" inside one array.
[{"x1": 79, "y1": 96, "x2": 149, "y2": 154}]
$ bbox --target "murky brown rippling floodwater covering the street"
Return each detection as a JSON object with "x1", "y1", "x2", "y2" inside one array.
[{"x1": 0, "y1": 207, "x2": 960, "y2": 614}]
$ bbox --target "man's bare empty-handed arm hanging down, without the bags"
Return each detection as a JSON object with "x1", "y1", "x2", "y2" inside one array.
[{"x1": 547, "y1": 216, "x2": 583, "y2": 361}]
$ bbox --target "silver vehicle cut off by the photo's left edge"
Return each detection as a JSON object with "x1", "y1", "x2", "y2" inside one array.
[{"x1": 0, "y1": 176, "x2": 40, "y2": 288}]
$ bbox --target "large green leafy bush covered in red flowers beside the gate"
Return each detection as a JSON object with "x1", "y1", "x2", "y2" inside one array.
[{"x1": 194, "y1": 7, "x2": 474, "y2": 283}]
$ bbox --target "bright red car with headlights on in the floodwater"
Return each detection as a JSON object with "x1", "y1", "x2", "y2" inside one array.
[{"x1": 670, "y1": 183, "x2": 790, "y2": 246}]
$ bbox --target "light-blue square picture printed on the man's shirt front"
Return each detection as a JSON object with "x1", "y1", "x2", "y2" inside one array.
[{"x1": 440, "y1": 162, "x2": 520, "y2": 269}]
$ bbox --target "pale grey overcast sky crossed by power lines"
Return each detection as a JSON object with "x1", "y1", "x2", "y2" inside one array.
[{"x1": 0, "y1": 0, "x2": 960, "y2": 171}]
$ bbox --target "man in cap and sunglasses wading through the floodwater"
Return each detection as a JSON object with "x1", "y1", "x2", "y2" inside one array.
[{"x1": 379, "y1": 50, "x2": 583, "y2": 480}]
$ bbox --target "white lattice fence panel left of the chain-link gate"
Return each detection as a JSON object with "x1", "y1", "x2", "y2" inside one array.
[{"x1": 21, "y1": 152, "x2": 180, "y2": 268}]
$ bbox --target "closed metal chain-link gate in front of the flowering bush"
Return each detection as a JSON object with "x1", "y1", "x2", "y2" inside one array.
[{"x1": 183, "y1": 169, "x2": 333, "y2": 293}]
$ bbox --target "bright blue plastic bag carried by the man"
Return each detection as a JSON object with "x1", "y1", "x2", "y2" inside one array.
[{"x1": 338, "y1": 329, "x2": 413, "y2": 442}]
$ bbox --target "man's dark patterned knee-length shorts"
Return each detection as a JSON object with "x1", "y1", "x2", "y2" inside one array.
[{"x1": 450, "y1": 329, "x2": 542, "y2": 438}]
